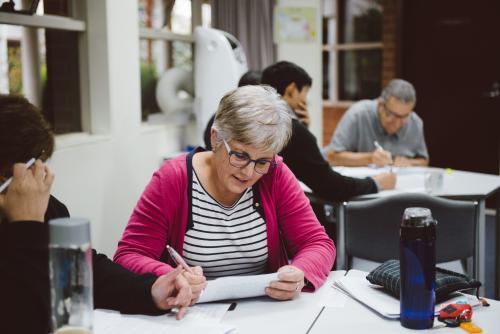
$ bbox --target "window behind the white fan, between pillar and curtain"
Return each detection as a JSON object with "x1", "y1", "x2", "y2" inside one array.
[{"x1": 139, "y1": 0, "x2": 206, "y2": 120}]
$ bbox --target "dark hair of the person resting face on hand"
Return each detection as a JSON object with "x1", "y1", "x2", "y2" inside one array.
[{"x1": 261, "y1": 61, "x2": 312, "y2": 95}]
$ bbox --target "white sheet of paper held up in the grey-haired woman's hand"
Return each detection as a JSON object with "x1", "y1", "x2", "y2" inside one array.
[{"x1": 198, "y1": 273, "x2": 278, "y2": 303}]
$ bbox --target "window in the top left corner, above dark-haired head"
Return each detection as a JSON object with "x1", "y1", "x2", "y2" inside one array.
[{"x1": 0, "y1": 0, "x2": 85, "y2": 134}]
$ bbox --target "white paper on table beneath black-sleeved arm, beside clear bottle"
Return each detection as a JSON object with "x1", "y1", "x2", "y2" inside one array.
[{"x1": 93, "y1": 304, "x2": 234, "y2": 334}]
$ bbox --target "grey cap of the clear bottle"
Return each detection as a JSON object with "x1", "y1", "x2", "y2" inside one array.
[{"x1": 49, "y1": 218, "x2": 90, "y2": 248}]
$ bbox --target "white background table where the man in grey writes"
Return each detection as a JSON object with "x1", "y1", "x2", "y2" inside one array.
[{"x1": 302, "y1": 167, "x2": 500, "y2": 298}]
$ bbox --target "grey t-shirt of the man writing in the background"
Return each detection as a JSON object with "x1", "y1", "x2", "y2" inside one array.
[{"x1": 325, "y1": 100, "x2": 429, "y2": 159}]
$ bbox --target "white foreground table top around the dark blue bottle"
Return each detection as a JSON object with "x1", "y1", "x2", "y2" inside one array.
[{"x1": 95, "y1": 271, "x2": 500, "y2": 334}]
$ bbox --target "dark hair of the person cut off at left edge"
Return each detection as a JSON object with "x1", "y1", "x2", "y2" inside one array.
[{"x1": 0, "y1": 94, "x2": 54, "y2": 175}]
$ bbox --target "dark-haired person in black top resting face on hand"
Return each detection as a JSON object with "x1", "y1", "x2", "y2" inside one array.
[{"x1": 261, "y1": 61, "x2": 396, "y2": 202}]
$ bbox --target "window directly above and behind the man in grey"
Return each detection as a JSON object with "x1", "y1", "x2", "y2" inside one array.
[{"x1": 323, "y1": 0, "x2": 383, "y2": 102}]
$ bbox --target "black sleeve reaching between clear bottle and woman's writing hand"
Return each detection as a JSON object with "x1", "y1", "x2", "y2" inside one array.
[{"x1": 93, "y1": 250, "x2": 166, "y2": 314}]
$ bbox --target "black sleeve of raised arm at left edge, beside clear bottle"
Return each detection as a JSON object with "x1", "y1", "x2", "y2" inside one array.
[{"x1": 0, "y1": 221, "x2": 50, "y2": 334}]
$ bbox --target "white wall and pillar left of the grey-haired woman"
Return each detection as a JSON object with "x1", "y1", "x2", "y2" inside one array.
[{"x1": 50, "y1": 0, "x2": 186, "y2": 256}]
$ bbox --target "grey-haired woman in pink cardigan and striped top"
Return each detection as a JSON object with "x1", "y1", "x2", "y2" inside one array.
[{"x1": 114, "y1": 86, "x2": 335, "y2": 303}]
